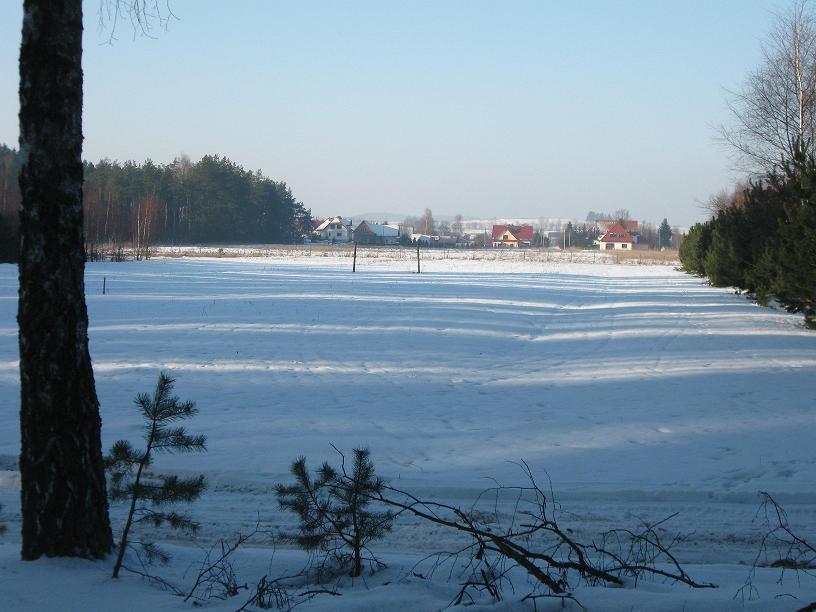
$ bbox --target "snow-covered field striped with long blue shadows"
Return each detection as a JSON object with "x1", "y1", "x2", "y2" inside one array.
[{"x1": 0, "y1": 252, "x2": 816, "y2": 610}]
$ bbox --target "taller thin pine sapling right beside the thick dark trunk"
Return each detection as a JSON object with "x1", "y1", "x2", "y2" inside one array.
[{"x1": 105, "y1": 372, "x2": 206, "y2": 578}]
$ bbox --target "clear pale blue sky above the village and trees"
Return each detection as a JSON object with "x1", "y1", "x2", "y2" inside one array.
[{"x1": 0, "y1": 0, "x2": 787, "y2": 225}]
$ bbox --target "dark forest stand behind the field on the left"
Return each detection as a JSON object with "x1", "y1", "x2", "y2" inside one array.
[{"x1": 0, "y1": 145, "x2": 312, "y2": 261}]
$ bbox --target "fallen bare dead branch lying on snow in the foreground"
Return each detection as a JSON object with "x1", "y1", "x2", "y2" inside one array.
[{"x1": 356, "y1": 461, "x2": 716, "y2": 605}]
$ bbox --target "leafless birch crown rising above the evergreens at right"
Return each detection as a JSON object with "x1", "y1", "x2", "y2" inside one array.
[{"x1": 720, "y1": 0, "x2": 816, "y2": 173}]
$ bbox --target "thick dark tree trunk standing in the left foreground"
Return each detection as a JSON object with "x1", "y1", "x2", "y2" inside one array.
[{"x1": 18, "y1": 0, "x2": 111, "y2": 560}]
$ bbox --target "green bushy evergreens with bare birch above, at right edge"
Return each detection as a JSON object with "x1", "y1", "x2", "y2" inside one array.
[{"x1": 680, "y1": 0, "x2": 816, "y2": 329}]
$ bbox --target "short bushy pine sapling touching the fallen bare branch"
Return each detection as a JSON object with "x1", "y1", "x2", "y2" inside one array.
[{"x1": 275, "y1": 448, "x2": 394, "y2": 578}]
